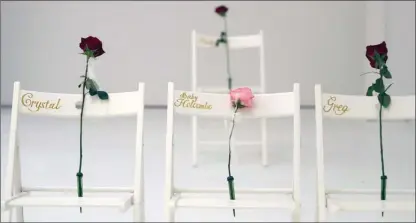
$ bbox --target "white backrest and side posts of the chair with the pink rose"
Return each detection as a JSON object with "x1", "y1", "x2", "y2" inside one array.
[{"x1": 166, "y1": 83, "x2": 300, "y2": 204}]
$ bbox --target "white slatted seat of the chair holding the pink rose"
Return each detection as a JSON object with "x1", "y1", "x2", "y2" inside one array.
[{"x1": 171, "y1": 188, "x2": 296, "y2": 210}]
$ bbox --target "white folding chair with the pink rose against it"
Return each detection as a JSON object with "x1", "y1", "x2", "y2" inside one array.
[{"x1": 165, "y1": 83, "x2": 300, "y2": 222}]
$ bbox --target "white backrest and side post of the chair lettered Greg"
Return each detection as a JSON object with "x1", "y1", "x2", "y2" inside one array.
[{"x1": 315, "y1": 85, "x2": 415, "y2": 211}]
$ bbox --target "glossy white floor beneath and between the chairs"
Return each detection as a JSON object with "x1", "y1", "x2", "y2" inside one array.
[{"x1": 1, "y1": 109, "x2": 415, "y2": 222}]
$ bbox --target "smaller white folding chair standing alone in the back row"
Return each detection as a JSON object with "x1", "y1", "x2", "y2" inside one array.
[{"x1": 191, "y1": 30, "x2": 268, "y2": 166}]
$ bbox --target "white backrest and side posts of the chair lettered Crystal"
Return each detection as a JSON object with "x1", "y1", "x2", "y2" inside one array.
[{"x1": 5, "y1": 82, "x2": 144, "y2": 205}]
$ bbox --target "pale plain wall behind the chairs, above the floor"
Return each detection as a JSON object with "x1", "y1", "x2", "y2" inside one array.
[{"x1": 1, "y1": 1, "x2": 415, "y2": 105}]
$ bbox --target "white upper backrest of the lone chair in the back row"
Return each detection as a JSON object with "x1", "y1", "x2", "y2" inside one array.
[{"x1": 191, "y1": 30, "x2": 266, "y2": 93}]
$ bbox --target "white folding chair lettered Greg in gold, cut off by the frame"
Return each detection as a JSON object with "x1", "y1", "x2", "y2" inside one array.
[{"x1": 315, "y1": 85, "x2": 415, "y2": 222}]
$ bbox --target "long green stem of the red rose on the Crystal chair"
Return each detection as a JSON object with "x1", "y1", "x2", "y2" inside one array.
[{"x1": 77, "y1": 55, "x2": 90, "y2": 213}]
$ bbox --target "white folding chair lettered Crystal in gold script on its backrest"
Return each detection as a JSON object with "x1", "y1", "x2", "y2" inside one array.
[{"x1": 2, "y1": 82, "x2": 145, "y2": 222}]
